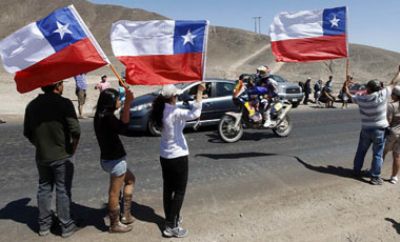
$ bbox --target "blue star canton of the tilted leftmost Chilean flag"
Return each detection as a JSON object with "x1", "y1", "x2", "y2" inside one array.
[{"x1": 36, "y1": 7, "x2": 87, "y2": 51}]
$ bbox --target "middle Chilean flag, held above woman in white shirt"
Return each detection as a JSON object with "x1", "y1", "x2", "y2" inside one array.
[{"x1": 111, "y1": 20, "x2": 209, "y2": 85}]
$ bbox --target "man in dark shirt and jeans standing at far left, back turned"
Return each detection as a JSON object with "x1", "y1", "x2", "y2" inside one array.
[{"x1": 24, "y1": 81, "x2": 80, "y2": 237}]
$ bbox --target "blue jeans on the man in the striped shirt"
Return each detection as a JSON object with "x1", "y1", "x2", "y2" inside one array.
[{"x1": 354, "y1": 128, "x2": 385, "y2": 177}]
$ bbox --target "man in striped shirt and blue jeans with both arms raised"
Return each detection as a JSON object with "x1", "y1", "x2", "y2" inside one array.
[{"x1": 343, "y1": 66, "x2": 400, "y2": 185}]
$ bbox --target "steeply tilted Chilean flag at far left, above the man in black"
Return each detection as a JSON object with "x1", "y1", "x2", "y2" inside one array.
[{"x1": 0, "y1": 5, "x2": 110, "y2": 93}]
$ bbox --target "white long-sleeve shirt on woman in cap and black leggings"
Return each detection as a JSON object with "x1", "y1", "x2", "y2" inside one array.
[{"x1": 160, "y1": 102, "x2": 201, "y2": 159}]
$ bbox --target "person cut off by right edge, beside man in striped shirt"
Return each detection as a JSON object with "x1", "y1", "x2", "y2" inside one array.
[{"x1": 383, "y1": 86, "x2": 400, "y2": 184}]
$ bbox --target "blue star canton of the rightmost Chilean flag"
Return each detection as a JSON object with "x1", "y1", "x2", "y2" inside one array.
[{"x1": 322, "y1": 7, "x2": 346, "y2": 35}]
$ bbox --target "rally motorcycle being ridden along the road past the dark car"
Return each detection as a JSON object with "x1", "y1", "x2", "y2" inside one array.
[{"x1": 218, "y1": 79, "x2": 292, "y2": 143}]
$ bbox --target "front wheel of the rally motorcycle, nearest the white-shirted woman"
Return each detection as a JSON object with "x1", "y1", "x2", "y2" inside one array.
[{"x1": 218, "y1": 115, "x2": 243, "y2": 143}]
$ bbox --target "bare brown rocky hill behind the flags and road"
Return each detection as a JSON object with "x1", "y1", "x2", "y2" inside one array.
[{"x1": 0, "y1": 0, "x2": 400, "y2": 89}]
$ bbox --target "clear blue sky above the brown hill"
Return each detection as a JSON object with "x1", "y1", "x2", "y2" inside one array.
[{"x1": 90, "y1": 0, "x2": 400, "y2": 52}]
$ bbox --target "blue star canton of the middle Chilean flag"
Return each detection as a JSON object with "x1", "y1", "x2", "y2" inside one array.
[{"x1": 174, "y1": 21, "x2": 207, "y2": 54}]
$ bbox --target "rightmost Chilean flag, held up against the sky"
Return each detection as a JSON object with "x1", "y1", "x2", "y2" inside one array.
[{"x1": 270, "y1": 7, "x2": 348, "y2": 62}]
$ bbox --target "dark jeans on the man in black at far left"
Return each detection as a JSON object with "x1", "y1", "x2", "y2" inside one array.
[{"x1": 37, "y1": 158, "x2": 74, "y2": 231}]
